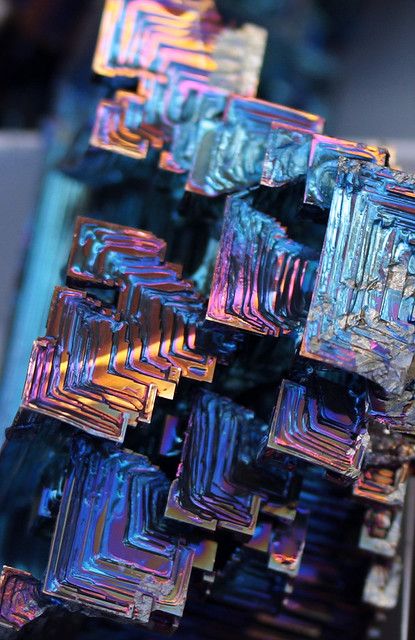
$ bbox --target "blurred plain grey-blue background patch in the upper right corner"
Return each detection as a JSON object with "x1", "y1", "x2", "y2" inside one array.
[{"x1": 328, "y1": 0, "x2": 415, "y2": 139}]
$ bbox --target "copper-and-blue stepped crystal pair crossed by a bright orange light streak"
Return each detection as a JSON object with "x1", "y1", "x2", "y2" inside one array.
[{"x1": 22, "y1": 218, "x2": 215, "y2": 442}]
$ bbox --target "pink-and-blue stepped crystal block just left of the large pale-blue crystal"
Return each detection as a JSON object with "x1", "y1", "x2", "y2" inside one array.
[{"x1": 206, "y1": 192, "x2": 317, "y2": 336}]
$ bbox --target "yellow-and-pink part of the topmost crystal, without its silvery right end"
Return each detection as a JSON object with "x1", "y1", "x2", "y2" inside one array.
[{"x1": 93, "y1": 0, "x2": 222, "y2": 78}]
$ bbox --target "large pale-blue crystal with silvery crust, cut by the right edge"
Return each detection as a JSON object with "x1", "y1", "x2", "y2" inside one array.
[{"x1": 302, "y1": 160, "x2": 415, "y2": 393}]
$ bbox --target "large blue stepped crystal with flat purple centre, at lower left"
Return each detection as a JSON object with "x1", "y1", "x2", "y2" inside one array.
[{"x1": 44, "y1": 438, "x2": 194, "y2": 626}]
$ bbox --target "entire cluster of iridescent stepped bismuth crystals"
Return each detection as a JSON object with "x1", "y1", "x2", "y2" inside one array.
[{"x1": 0, "y1": 0, "x2": 415, "y2": 640}]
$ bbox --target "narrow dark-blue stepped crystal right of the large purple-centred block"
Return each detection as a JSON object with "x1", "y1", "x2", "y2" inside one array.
[{"x1": 166, "y1": 392, "x2": 264, "y2": 535}]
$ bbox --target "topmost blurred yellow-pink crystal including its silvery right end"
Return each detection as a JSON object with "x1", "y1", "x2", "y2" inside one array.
[{"x1": 93, "y1": 0, "x2": 266, "y2": 95}]
